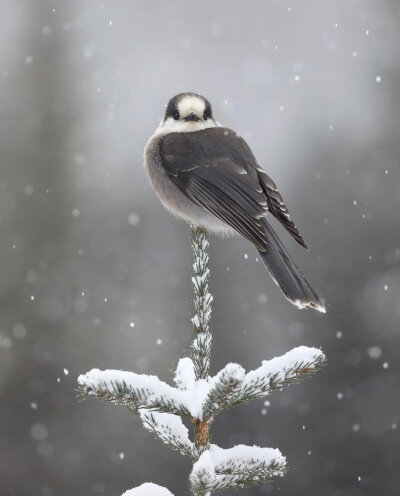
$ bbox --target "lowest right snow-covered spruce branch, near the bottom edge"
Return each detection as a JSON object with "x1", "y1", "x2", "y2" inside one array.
[{"x1": 190, "y1": 445, "x2": 286, "y2": 495}]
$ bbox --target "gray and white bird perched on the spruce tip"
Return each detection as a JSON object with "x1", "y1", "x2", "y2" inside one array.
[{"x1": 144, "y1": 93, "x2": 326, "y2": 313}]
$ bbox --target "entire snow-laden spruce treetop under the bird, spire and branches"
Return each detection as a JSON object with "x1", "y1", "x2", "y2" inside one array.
[{"x1": 78, "y1": 228, "x2": 325, "y2": 496}]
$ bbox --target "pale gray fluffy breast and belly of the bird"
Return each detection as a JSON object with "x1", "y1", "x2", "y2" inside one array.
[{"x1": 144, "y1": 135, "x2": 234, "y2": 234}]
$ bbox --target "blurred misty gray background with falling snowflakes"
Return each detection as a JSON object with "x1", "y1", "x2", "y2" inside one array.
[{"x1": 0, "y1": 0, "x2": 400, "y2": 496}]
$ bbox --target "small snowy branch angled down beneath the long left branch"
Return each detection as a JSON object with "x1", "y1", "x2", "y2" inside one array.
[{"x1": 139, "y1": 409, "x2": 193, "y2": 457}]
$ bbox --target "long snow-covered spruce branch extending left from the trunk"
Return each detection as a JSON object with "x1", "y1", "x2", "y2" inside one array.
[{"x1": 78, "y1": 369, "x2": 190, "y2": 416}]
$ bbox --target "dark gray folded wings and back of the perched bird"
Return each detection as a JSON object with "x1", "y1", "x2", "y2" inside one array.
[{"x1": 160, "y1": 127, "x2": 307, "y2": 251}]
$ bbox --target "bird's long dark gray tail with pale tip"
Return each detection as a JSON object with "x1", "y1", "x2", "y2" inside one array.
[{"x1": 259, "y1": 221, "x2": 326, "y2": 313}]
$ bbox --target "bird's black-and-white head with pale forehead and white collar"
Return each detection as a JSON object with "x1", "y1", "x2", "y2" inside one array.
[{"x1": 160, "y1": 93, "x2": 218, "y2": 133}]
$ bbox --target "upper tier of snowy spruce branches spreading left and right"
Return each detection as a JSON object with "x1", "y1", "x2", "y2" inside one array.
[{"x1": 78, "y1": 346, "x2": 325, "y2": 421}]
